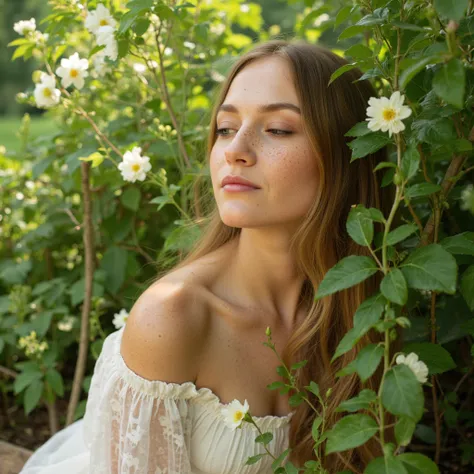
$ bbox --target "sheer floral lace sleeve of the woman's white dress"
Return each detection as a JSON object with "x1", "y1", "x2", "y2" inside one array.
[{"x1": 84, "y1": 330, "x2": 196, "y2": 474}]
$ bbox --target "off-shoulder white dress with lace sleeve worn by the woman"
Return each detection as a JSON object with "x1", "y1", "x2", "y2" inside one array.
[{"x1": 20, "y1": 328, "x2": 293, "y2": 474}]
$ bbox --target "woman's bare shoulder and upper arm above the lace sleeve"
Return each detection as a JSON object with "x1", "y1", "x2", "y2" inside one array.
[{"x1": 120, "y1": 281, "x2": 205, "y2": 383}]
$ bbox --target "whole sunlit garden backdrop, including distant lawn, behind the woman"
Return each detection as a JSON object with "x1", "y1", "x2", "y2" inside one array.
[{"x1": 0, "y1": 0, "x2": 474, "y2": 474}]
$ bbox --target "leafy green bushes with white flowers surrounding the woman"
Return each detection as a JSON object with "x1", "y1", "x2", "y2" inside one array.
[{"x1": 0, "y1": 0, "x2": 474, "y2": 474}]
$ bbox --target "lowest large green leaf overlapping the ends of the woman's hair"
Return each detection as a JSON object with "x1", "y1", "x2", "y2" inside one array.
[{"x1": 326, "y1": 414, "x2": 378, "y2": 455}]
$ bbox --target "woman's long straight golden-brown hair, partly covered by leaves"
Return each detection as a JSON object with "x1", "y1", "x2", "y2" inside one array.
[{"x1": 156, "y1": 40, "x2": 393, "y2": 472}]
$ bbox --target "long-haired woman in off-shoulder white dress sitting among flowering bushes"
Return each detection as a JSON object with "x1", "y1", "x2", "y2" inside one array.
[{"x1": 22, "y1": 40, "x2": 392, "y2": 474}]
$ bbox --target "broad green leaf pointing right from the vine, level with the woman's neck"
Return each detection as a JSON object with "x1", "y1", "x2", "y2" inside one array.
[{"x1": 400, "y1": 244, "x2": 457, "y2": 295}]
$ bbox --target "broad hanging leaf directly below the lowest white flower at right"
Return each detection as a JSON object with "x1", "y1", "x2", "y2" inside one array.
[{"x1": 382, "y1": 364, "x2": 424, "y2": 422}]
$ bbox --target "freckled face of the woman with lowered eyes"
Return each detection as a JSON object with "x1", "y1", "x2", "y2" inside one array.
[{"x1": 210, "y1": 57, "x2": 318, "y2": 229}]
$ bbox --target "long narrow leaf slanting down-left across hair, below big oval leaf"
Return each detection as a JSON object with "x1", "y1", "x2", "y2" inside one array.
[{"x1": 331, "y1": 292, "x2": 386, "y2": 362}]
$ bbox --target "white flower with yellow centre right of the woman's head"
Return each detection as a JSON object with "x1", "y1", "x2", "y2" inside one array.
[{"x1": 366, "y1": 91, "x2": 411, "y2": 136}]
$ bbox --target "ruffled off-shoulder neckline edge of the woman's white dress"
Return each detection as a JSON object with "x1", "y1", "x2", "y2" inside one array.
[{"x1": 113, "y1": 326, "x2": 294, "y2": 429}]
